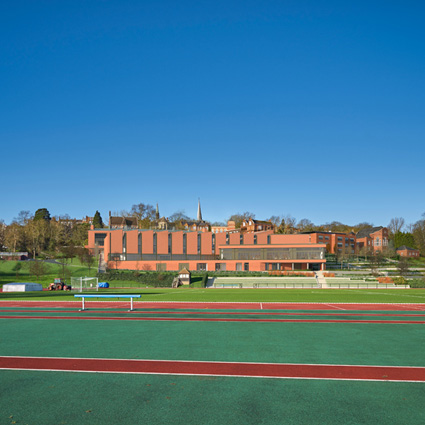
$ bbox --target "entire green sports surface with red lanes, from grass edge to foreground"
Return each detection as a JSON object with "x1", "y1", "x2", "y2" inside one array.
[{"x1": 0, "y1": 301, "x2": 425, "y2": 425}]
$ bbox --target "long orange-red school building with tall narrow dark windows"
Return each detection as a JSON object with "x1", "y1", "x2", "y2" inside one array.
[{"x1": 88, "y1": 228, "x2": 326, "y2": 271}]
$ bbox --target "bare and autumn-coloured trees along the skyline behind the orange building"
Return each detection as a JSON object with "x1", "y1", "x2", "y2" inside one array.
[{"x1": 0, "y1": 203, "x2": 425, "y2": 258}]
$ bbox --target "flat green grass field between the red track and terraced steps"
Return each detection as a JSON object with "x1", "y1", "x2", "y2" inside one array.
[{"x1": 0, "y1": 287, "x2": 425, "y2": 303}]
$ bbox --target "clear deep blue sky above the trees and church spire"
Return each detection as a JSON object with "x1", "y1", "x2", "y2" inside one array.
[{"x1": 0, "y1": 0, "x2": 425, "y2": 225}]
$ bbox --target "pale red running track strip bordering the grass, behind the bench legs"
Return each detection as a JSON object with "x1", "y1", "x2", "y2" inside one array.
[{"x1": 0, "y1": 300, "x2": 425, "y2": 311}]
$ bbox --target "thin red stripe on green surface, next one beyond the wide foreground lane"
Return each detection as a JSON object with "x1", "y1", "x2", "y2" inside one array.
[{"x1": 0, "y1": 316, "x2": 425, "y2": 325}]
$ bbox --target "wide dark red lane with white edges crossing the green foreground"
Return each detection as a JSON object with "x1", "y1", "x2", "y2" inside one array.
[{"x1": 0, "y1": 356, "x2": 425, "y2": 382}]
